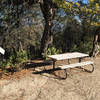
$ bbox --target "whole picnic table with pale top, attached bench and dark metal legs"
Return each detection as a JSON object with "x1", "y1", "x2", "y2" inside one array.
[{"x1": 48, "y1": 52, "x2": 94, "y2": 78}]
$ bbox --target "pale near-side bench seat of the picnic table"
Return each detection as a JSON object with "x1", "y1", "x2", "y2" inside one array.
[{"x1": 59, "y1": 61, "x2": 94, "y2": 69}]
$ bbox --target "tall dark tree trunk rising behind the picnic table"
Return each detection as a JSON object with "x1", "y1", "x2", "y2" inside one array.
[{"x1": 40, "y1": 0, "x2": 55, "y2": 54}]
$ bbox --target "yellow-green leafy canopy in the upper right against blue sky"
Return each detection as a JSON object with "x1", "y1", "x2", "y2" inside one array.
[{"x1": 53, "y1": 0, "x2": 100, "y2": 26}]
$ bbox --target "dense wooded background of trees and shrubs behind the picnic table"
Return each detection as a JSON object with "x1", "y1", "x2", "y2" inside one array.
[{"x1": 0, "y1": 0, "x2": 100, "y2": 69}]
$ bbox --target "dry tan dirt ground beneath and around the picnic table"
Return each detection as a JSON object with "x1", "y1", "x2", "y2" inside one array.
[{"x1": 0, "y1": 56, "x2": 100, "y2": 100}]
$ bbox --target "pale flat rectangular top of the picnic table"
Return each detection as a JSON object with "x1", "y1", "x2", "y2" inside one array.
[{"x1": 48, "y1": 52, "x2": 89, "y2": 60}]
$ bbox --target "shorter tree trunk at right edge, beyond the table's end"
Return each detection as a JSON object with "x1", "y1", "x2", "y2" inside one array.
[{"x1": 90, "y1": 27, "x2": 100, "y2": 57}]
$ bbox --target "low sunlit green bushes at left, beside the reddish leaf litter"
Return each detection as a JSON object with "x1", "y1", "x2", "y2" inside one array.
[{"x1": 0, "y1": 50, "x2": 28, "y2": 70}]
